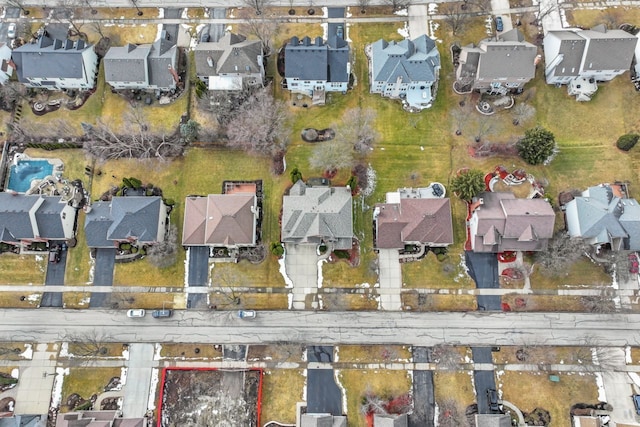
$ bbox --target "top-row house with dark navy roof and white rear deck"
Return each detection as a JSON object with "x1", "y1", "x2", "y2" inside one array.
[{"x1": 284, "y1": 35, "x2": 351, "y2": 104}]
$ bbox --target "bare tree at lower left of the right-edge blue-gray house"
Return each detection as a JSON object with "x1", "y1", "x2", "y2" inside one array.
[{"x1": 535, "y1": 231, "x2": 588, "y2": 275}]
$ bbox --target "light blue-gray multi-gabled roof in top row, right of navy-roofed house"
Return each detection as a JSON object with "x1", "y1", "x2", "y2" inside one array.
[{"x1": 371, "y1": 35, "x2": 440, "y2": 83}]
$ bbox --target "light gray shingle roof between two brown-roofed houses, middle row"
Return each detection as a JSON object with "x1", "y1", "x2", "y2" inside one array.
[{"x1": 282, "y1": 182, "x2": 353, "y2": 249}]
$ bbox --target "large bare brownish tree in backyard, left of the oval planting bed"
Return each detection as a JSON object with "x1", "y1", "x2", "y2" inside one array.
[{"x1": 226, "y1": 86, "x2": 289, "y2": 156}]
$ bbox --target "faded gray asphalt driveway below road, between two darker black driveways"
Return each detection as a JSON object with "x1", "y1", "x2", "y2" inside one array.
[{"x1": 409, "y1": 347, "x2": 435, "y2": 427}]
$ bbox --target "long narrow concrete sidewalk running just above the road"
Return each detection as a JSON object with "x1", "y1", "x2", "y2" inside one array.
[{"x1": 0, "y1": 285, "x2": 640, "y2": 297}]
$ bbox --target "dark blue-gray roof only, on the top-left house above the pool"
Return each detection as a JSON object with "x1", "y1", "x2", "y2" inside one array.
[{"x1": 12, "y1": 36, "x2": 93, "y2": 82}]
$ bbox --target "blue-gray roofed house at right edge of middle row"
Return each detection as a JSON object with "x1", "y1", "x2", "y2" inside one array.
[{"x1": 564, "y1": 184, "x2": 640, "y2": 251}]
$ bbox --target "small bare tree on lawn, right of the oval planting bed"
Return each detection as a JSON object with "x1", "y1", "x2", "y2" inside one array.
[{"x1": 336, "y1": 107, "x2": 378, "y2": 154}]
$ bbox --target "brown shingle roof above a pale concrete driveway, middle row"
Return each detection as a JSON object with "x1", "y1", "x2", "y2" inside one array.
[{"x1": 376, "y1": 198, "x2": 453, "y2": 249}]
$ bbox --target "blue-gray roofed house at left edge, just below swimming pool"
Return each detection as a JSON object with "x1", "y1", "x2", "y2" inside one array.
[{"x1": 0, "y1": 193, "x2": 77, "y2": 251}]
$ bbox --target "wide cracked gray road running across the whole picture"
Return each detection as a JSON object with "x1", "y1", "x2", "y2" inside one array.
[{"x1": 0, "y1": 308, "x2": 640, "y2": 346}]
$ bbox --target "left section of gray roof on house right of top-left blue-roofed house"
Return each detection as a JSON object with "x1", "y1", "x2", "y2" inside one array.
[{"x1": 103, "y1": 43, "x2": 151, "y2": 82}]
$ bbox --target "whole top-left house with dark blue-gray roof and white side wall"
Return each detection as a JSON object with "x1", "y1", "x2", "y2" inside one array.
[{"x1": 11, "y1": 35, "x2": 98, "y2": 90}]
